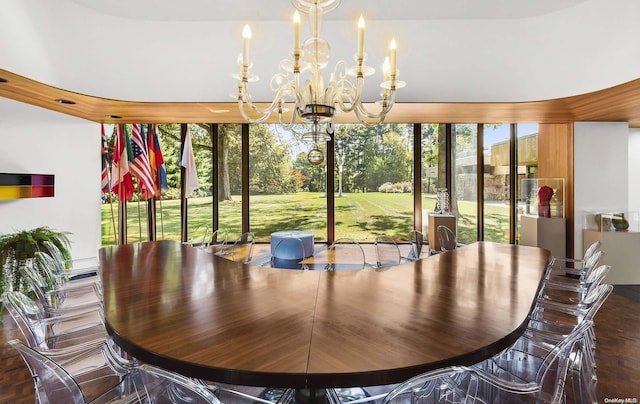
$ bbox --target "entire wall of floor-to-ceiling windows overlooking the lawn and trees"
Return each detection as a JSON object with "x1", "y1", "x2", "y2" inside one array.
[{"x1": 102, "y1": 118, "x2": 537, "y2": 245}]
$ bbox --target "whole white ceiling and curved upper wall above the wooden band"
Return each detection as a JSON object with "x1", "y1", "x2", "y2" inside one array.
[{"x1": 0, "y1": 0, "x2": 640, "y2": 109}]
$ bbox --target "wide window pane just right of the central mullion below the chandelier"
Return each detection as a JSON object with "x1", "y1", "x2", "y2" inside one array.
[{"x1": 334, "y1": 124, "x2": 413, "y2": 242}]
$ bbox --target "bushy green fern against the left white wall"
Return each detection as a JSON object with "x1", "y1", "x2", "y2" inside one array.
[{"x1": 0, "y1": 226, "x2": 71, "y2": 302}]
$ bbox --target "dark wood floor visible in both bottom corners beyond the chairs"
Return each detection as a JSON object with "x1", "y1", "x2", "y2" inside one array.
[{"x1": 0, "y1": 286, "x2": 640, "y2": 403}]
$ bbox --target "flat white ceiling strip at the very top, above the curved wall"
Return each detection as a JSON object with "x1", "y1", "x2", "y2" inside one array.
[{"x1": 72, "y1": 0, "x2": 586, "y2": 21}]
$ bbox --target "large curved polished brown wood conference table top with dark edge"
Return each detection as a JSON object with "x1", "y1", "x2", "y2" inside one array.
[{"x1": 99, "y1": 241, "x2": 549, "y2": 388}]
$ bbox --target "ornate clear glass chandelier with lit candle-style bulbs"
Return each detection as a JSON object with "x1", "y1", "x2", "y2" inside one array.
[{"x1": 232, "y1": 0, "x2": 405, "y2": 137}]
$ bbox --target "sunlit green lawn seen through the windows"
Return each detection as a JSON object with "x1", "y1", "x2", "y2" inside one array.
[{"x1": 102, "y1": 192, "x2": 509, "y2": 245}]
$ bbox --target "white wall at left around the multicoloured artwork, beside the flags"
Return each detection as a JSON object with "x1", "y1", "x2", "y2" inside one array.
[{"x1": 0, "y1": 100, "x2": 101, "y2": 258}]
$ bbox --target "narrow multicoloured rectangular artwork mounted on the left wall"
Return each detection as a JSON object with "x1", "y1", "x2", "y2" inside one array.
[{"x1": 0, "y1": 173, "x2": 54, "y2": 200}]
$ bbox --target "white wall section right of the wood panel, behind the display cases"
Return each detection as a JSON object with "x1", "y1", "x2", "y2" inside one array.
[{"x1": 574, "y1": 122, "x2": 637, "y2": 257}]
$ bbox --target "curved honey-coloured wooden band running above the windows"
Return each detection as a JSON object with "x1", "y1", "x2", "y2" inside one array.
[{"x1": 0, "y1": 69, "x2": 640, "y2": 128}]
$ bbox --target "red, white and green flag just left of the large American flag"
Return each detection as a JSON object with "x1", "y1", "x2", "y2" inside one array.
[{"x1": 111, "y1": 124, "x2": 133, "y2": 202}]
